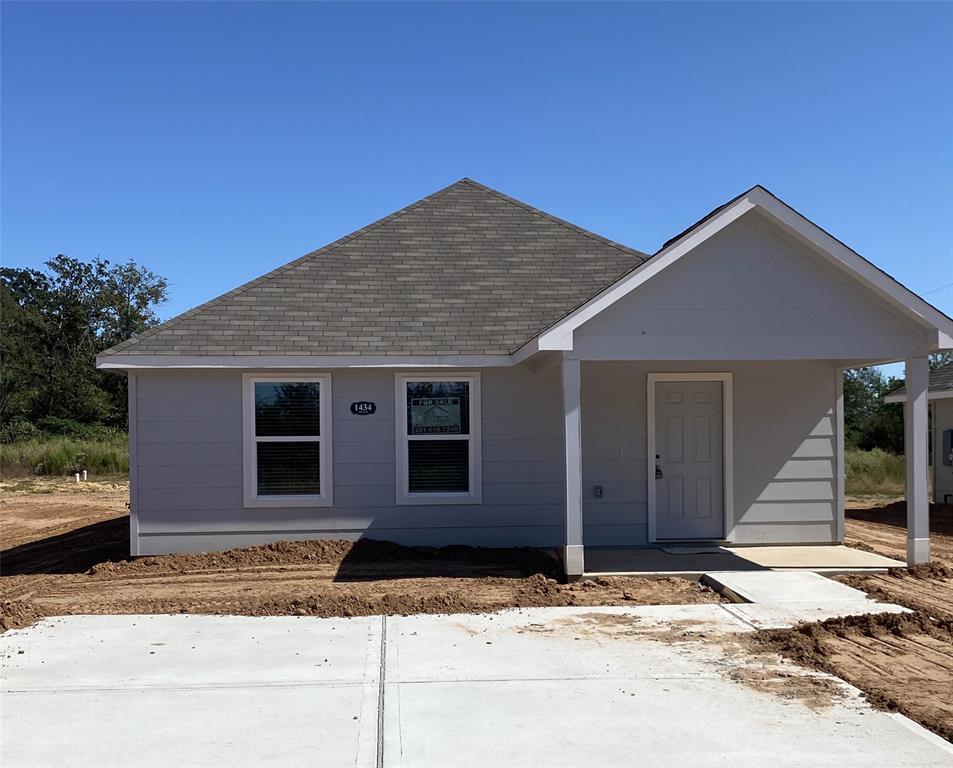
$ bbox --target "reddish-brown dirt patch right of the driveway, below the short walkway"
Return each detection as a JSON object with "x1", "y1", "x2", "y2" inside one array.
[{"x1": 750, "y1": 612, "x2": 953, "y2": 740}]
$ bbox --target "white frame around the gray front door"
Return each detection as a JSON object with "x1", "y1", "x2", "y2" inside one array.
[{"x1": 645, "y1": 372, "x2": 735, "y2": 544}]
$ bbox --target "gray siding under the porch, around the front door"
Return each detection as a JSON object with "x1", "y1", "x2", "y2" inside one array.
[{"x1": 582, "y1": 361, "x2": 840, "y2": 546}]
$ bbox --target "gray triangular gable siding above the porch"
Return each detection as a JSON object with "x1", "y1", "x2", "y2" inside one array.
[{"x1": 574, "y1": 208, "x2": 927, "y2": 360}]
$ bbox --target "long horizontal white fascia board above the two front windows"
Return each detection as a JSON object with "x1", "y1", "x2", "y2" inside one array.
[{"x1": 96, "y1": 339, "x2": 539, "y2": 371}]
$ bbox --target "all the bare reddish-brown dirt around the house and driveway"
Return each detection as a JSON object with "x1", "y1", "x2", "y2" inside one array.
[{"x1": 0, "y1": 480, "x2": 953, "y2": 739}]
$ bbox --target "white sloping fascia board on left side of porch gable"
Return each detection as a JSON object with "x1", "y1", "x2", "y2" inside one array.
[{"x1": 538, "y1": 194, "x2": 754, "y2": 351}]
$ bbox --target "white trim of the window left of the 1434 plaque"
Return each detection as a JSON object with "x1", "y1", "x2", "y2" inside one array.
[{"x1": 242, "y1": 373, "x2": 334, "y2": 508}]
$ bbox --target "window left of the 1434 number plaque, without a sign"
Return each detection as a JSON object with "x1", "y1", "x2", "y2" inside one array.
[{"x1": 242, "y1": 375, "x2": 331, "y2": 507}]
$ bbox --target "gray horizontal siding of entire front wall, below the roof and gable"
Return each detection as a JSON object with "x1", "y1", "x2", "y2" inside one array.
[{"x1": 134, "y1": 362, "x2": 836, "y2": 554}]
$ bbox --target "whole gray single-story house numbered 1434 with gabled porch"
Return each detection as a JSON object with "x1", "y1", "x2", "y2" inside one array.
[{"x1": 98, "y1": 179, "x2": 953, "y2": 575}]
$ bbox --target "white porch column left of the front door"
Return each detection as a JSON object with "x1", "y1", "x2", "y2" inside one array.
[{"x1": 562, "y1": 358, "x2": 583, "y2": 578}]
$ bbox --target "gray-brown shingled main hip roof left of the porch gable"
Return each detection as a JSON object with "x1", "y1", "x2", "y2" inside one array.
[{"x1": 102, "y1": 179, "x2": 648, "y2": 357}]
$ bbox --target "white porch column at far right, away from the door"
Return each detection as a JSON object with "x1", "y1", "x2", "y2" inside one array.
[{"x1": 903, "y1": 357, "x2": 930, "y2": 566}]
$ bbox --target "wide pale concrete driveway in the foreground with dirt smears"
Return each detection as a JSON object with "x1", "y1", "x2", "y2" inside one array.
[{"x1": 0, "y1": 605, "x2": 953, "y2": 768}]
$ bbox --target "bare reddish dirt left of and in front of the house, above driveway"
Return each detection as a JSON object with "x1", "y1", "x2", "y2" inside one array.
[{"x1": 0, "y1": 476, "x2": 720, "y2": 629}]
